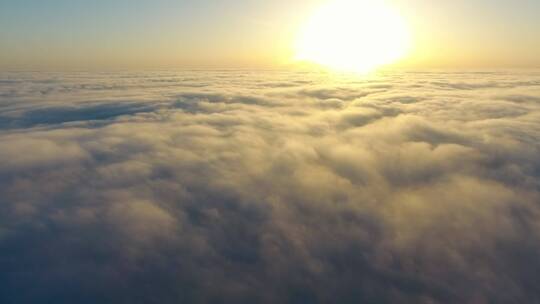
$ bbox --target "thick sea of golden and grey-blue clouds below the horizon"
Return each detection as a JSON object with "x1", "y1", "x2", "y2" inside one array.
[{"x1": 0, "y1": 70, "x2": 540, "y2": 304}]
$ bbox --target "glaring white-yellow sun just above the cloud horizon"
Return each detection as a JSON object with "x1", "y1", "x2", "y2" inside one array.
[{"x1": 295, "y1": 0, "x2": 410, "y2": 73}]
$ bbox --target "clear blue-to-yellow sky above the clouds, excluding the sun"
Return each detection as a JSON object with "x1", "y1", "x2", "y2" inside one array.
[{"x1": 0, "y1": 0, "x2": 540, "y2": 70}]
